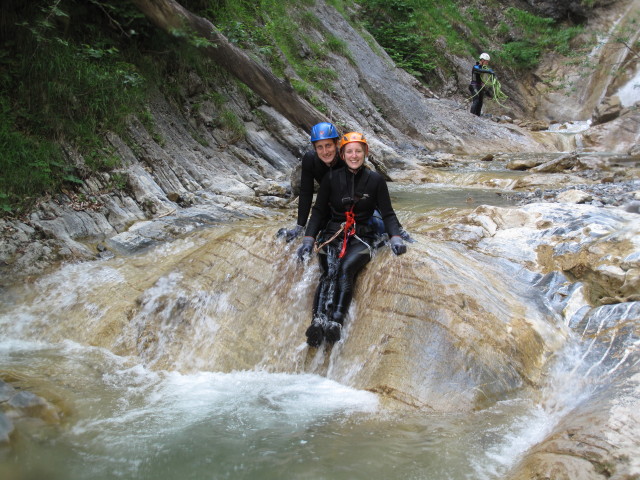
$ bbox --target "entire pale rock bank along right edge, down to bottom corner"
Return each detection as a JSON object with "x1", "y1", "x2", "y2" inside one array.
[{"x1": 437, "y1": 203, "x2": 640, "y2": 480}]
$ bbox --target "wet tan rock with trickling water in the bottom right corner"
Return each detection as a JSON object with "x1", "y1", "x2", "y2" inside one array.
[{"x1": 506, "y1": 302, "x2": 640, "y2": 480}]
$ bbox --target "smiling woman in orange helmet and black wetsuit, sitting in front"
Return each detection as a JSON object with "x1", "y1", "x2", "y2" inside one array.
[{"x1": 298, "y1": 132, "x2": 407, "y2": 347}]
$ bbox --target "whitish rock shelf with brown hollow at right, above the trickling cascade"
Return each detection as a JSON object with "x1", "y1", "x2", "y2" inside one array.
[{"x1": 431, "y1": 202, "x2": 640, "y2": 305}]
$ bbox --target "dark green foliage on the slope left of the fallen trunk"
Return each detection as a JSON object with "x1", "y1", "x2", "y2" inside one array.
[{"x1": 0, "y1": 0, "x2": 237, "y2": 213}]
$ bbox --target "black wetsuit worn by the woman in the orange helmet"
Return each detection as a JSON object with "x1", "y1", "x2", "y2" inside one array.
[{"x1": 305, "y1": 167, "x2": 401, "y2": 324}]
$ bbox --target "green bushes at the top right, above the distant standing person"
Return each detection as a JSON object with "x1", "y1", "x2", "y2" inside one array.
[{"x1": 358, "y1": 0, "x2": 581, "y2": 81}]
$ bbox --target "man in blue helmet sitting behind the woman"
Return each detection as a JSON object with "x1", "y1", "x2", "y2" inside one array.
[{"x1": 278, "y1": 122, "x2": 344, "y2": 242}]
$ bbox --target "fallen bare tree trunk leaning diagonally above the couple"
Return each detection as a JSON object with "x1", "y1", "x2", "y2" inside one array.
[{"x1": 132, "y1": 0, "x2": 328, "y2": 131}]
